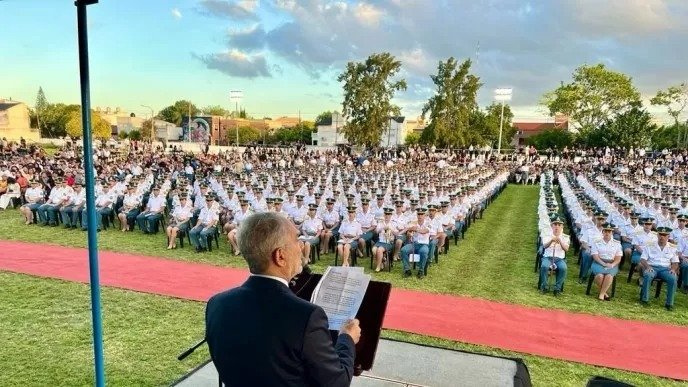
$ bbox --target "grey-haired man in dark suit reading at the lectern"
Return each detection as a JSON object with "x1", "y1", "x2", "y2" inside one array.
[{"x1": 206, "y1": 212, "x2": 361, "y2": 387}]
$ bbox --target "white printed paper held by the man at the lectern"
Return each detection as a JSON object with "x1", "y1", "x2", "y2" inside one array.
[{"x1": 311, "y1": 266, "x2": 370, "y2": 331}]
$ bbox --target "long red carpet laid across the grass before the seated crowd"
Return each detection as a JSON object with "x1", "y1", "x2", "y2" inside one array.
[{"x1": 0, "y1": 241, "x2": 688, "y2": 380}]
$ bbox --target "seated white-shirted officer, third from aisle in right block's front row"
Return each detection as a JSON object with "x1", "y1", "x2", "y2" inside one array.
[{"x1": 640, "y1": 227, "x2": 679, "y2": 310}]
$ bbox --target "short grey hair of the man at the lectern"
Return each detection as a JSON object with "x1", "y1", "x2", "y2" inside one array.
[{"x1": 237, "y1": 212, "x2": 289, "y2": 274}]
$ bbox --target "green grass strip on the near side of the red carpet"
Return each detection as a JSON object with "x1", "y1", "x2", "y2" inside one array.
[{"x1": 0, "y1": 272, "x2": 681, "y2": 386}]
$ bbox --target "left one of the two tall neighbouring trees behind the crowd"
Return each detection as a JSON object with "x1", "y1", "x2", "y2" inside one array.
[{"x1": 337, "y1": 52, "x2": 406, "y2": 146}]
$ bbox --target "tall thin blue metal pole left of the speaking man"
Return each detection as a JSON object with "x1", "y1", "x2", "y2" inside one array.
[{"x1": 74, "y1": 0, "x2": 105, "y2": 387}]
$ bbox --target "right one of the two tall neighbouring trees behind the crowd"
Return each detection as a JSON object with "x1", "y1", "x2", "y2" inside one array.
[{"x1": 421, "y1": 57, "x2": 482, "y2": 147}]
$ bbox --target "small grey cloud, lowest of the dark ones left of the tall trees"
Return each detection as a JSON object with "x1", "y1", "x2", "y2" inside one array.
[{"x1": 194, "y1": 49, "x2": 271, "y2": 78}]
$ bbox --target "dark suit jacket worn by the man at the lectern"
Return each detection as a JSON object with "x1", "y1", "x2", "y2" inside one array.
[{"x1": 206, "y1": 276, "x2": 355, "y2": 387}]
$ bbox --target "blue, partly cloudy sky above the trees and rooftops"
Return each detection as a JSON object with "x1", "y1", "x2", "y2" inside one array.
[{"x1": 0, "y1": 0, "x2": 688, "y2": 119}]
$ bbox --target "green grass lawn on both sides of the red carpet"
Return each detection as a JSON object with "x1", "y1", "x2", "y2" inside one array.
[{"x1": 0, "y1": 186, "x2": 688, "y2": 386}]
